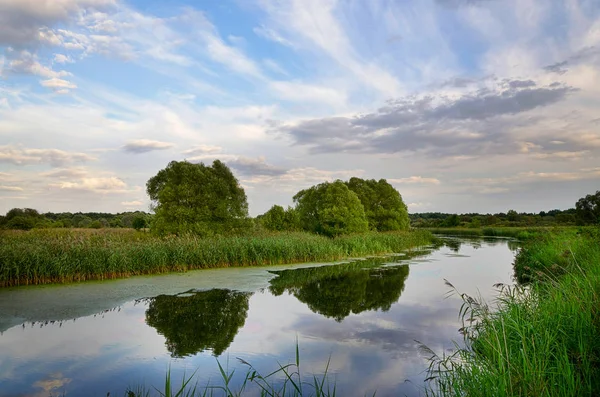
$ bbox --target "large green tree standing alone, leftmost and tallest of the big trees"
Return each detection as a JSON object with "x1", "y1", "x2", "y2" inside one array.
[{"x1": 146, "y1": 160, "x2": 248, "y2": 235}]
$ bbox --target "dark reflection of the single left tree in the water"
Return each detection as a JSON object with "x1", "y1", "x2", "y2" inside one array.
[{"x1": 146, "y1": 289, "x2": 251, "y2": 357}]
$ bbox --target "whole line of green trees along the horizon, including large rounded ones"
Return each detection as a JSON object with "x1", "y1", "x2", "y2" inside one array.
[{"x1": 0, "y1": 160, "x2": 600, "y2": 232}]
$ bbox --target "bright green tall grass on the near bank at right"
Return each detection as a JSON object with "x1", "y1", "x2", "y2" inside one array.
[{"x1": 425, "y1": 229, "x2": 600, "y2": 396}]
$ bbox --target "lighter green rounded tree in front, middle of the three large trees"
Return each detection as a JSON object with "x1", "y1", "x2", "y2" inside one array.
[{"x1": 294, "y1": 180, "x2": 369, "y2": 237}]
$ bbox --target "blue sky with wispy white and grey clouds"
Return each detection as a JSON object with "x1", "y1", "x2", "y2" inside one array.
[{"x1": 0, "y1": 0, "x2": 600, "y2": 215}]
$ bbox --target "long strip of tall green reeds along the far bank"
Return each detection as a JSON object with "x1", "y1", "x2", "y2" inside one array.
[{"x1": 0, "y1": 229, "x2": 433, "y2": 286}]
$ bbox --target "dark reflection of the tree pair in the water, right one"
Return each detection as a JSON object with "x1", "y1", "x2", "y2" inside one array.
[{"x1": 269, "y1": 257, "x2": 409, "y2": 322}]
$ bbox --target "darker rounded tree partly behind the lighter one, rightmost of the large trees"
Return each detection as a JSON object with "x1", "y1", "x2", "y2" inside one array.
[{"x1": 346, "y1": 178, "x2": 410, "y2": 232}]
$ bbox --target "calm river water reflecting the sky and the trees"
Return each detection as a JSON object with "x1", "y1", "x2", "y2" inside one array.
[{"x1": 0, "y1": 239, "x2": 515, "y2": 397}]
